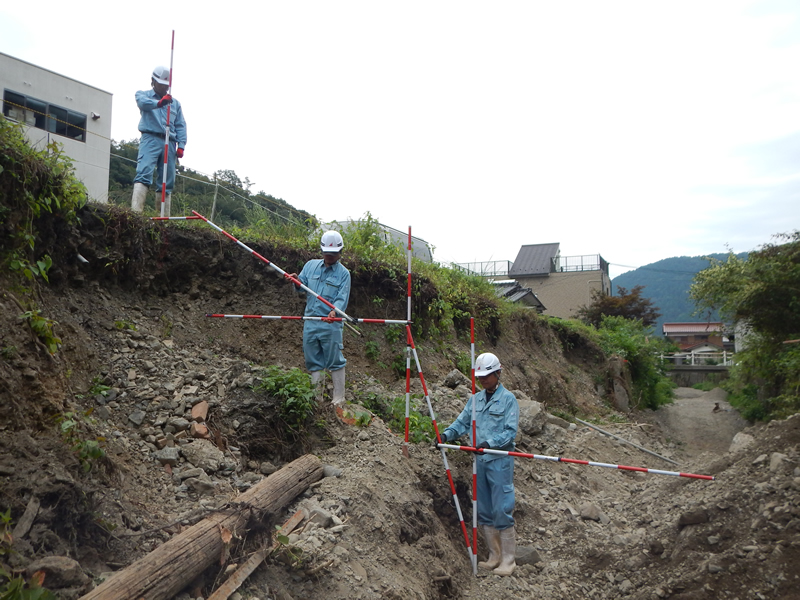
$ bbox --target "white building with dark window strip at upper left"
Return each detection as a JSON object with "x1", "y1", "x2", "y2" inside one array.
[{"x1": 0, "y1": 52, "x2": 111, "y2": 202}]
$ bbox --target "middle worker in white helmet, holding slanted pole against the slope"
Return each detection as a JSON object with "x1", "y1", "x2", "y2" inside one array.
[{"x1": 289, "y1": 231, "x2": 350, "y2": 417}]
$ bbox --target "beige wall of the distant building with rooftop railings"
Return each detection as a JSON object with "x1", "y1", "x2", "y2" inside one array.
[{"x1": 515, "y1": 271, "x2": 611, "y2": 319}]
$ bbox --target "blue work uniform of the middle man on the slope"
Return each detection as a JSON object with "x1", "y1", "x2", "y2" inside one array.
[{"x1": 297, "y1": 258, "x2": 350, "y2": 371}]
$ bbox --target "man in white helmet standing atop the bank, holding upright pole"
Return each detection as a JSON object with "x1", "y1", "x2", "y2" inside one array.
[{"x1": 131, "y1": 67, "x2": 186, "y2": 217}]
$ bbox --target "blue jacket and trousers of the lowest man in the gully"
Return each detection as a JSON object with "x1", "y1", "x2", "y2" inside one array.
[{"x1": 444, "y1": 383, "x2": 519, "y2": 531}]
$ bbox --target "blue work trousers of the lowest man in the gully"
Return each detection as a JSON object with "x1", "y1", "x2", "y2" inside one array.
[{"x1": 478, "y1": 456, "x2": 514, "y2": 531}]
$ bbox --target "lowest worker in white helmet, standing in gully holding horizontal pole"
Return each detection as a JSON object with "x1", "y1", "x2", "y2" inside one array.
[{"x1": 437, "y1": 352, "x2": 519, "y2": 575}]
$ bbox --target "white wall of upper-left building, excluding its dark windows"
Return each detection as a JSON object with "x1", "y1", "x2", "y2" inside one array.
[{"x1": 0, "y1": 53, "x2": 112, "y2": 202}]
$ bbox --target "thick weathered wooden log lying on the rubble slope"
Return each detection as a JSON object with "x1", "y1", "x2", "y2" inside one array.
[{"x1": 81, "y1": 454, "x2": 322, "y2": 600}]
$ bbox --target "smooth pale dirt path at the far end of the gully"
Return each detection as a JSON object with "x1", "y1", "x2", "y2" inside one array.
[{"x1": 656, "y1": 388, "x2": 747, "y2": 457}]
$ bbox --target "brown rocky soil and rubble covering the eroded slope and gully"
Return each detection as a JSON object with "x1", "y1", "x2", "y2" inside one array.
[{"x1": 0, "y1": 205, "x2": 800, "y2": 600}]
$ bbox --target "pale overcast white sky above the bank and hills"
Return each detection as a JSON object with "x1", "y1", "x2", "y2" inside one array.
[{"x1": 0, "y1": 0, "x2": 800, "y2": 277}]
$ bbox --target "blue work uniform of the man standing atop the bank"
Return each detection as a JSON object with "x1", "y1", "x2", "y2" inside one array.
[{"x1": 133, "y1": 90, "x2": 191, "y2": 194}]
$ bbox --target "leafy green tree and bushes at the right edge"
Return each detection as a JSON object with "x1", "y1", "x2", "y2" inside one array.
[{"x1": 690, "y1": 231, "x2": 800, "y2": 420}]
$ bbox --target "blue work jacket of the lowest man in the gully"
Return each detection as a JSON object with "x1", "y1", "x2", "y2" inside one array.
[{"x1": 444, "y1": 383, "x2": 519, "y2": 460}]
